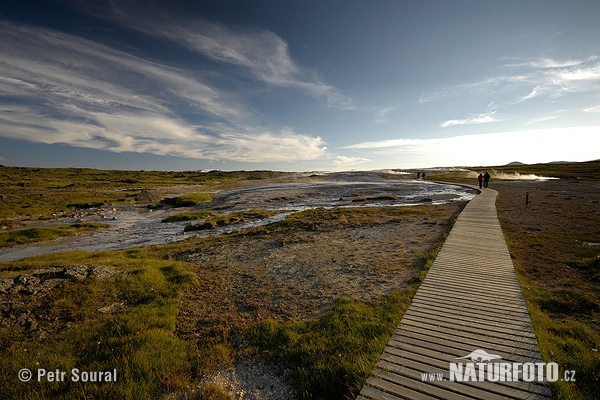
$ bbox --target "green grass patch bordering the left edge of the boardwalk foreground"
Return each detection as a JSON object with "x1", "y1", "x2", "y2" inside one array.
[{"x1": 244, "y1": 240, "x2": 443, "y2": 400}]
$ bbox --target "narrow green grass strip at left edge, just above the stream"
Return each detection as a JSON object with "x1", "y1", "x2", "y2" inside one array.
[{"x1": 0, "y1": 222, "x2": 110, "y2": 247}]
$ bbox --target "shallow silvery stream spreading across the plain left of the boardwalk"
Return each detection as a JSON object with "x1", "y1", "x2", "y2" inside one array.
[{"x1": 0, "y1": 172, "x2": 475, "y2": 261}]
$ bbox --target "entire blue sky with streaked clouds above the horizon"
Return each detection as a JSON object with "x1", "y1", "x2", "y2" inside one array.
[{"x1": 0, "y1": 0, "x2": 600, "y2": 171}]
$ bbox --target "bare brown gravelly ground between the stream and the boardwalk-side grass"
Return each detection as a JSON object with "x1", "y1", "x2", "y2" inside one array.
[{"x1": 177, "y1": 203, "x2": 464, "y2": 339}]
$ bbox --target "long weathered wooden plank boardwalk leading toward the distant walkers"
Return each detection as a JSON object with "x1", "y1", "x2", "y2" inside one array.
[{"x1": 357, "y1": 189, "x2": 552, "y2": 400}]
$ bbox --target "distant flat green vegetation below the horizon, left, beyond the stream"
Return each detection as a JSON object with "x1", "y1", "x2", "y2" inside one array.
[{"x1": 0, "y1": 166, "x2": 290, "y2": 219}]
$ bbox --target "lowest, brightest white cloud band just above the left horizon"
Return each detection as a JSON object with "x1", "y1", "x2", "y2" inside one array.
[{"x1": 0, "y1": 108, "x2": 327, "y2": 162}]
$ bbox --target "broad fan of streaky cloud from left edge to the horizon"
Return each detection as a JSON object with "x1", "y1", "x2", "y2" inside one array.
[{"x1": 0, "y1": 22, "x2": 328, "y2": 162}]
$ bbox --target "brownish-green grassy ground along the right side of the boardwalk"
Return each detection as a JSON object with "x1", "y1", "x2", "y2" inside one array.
[{"x1": 498, "y1": 184, "x2": 600, "y2": 399}]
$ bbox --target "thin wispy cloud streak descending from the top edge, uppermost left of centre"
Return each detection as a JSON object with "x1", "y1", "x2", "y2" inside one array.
[{"x1": 71, "y1": 1, "x2": 355, "y2": 109}]
